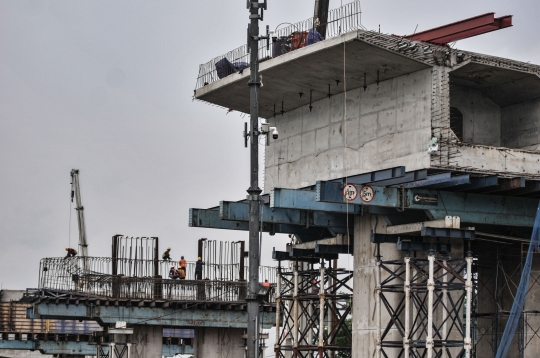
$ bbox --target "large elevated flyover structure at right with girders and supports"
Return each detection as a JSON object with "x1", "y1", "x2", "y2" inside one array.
[{"x1": 194, "y1": 3, "x2": 540, "y2": 357}]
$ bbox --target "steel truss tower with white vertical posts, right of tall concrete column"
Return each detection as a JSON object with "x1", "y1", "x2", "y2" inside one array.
[{"x1": 377, "y1": 251, "x2": 475, "y2": 358}]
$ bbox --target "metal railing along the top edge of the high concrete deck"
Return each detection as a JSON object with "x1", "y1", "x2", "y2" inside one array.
[{"x1": 195, "y1": 0, "x2": 364, "y2": 90}]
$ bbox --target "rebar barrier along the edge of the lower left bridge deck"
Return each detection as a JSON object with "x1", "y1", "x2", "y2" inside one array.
[{"x1": 39, "y1": 257, "x2": 275, "y2": 302}]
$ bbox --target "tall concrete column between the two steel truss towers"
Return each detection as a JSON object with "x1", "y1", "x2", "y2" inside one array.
[{"x1": 352, "y1": 214, "x2": 398, "y2": 358}]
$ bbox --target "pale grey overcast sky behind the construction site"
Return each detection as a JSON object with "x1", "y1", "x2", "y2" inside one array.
[{"x1": 0, "y1": 0, "x2": 540, "y2": 289}]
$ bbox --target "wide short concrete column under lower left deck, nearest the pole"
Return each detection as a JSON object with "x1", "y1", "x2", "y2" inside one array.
[{"x1": 193, "y1": 327, "x2": 245, "y2": 358}]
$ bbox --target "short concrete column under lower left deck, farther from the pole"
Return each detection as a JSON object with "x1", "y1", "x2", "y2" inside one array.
[{"x1": 130, "y1": 325, "x2": 163, "y2": 358}]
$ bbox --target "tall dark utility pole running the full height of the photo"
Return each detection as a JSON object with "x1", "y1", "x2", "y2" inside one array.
[{"x1": 244, "y1": 0, "x2": 268, "y2": 358}]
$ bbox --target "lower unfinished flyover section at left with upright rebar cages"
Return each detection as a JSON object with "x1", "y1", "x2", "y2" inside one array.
[{"x1": 14, "y1": 238, "x2": 275, "y2": 358}]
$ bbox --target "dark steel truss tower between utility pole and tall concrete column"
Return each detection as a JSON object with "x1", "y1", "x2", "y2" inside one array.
[{"x1": 274, "y1": 263, "x2": 353, "y2": 358}]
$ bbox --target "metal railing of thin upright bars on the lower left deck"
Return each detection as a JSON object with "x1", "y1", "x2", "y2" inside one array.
[{"x1": 39, "y1": 257, "x2": 276, "y2": 301}]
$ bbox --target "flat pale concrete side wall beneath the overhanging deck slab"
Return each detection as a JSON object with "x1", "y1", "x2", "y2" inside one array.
[{"x1": 265, "y1": 69, "x2": 431, "y2": 191}]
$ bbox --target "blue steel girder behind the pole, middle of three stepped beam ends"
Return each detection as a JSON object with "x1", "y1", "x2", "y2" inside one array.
[{"x1": 219, "y1": 201, "x2": 347, "y2": 228}]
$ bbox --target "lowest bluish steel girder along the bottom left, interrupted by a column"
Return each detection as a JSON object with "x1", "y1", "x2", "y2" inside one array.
[{"x1": 0, "y1": 340, "x2": 193, "y2": 357}]
